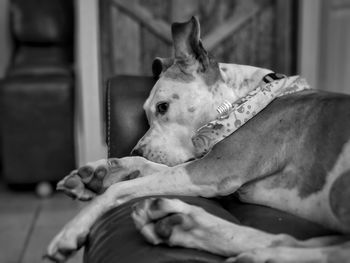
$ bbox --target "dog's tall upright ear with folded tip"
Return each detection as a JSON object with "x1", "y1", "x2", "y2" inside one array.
[{"x1": 171, "y1": 17, "x2": 209, "y2": 70}]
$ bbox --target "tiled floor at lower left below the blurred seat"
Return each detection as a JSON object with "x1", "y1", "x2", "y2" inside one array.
[{"x1": 0, "y1": 185, "x2": 83, "y2": 263}]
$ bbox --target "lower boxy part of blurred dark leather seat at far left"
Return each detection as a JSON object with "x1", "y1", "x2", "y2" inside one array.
[{"x1": 0, "y1": 76, "x2": 75, "y2": 184}]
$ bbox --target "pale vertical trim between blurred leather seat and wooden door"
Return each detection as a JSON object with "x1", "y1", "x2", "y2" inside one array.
[{"x1": 75, "y1": 0, "x2": 107, "y2": 166}]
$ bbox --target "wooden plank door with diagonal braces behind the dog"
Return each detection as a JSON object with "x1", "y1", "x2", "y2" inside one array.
[{"x1": 100, "y1": 0, "x2": 296, "y2": 83}]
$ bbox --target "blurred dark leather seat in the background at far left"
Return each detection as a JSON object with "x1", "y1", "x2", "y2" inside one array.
[{"x1": 0, "y1": 0, "x2": 75, "y2": 187}]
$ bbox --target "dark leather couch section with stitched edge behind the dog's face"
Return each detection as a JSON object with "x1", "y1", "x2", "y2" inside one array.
[{"x1": 106, "y1": 76, "x2": 155, "y2": 158}]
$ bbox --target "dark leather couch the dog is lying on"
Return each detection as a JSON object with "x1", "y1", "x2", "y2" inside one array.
[{"x1": 84, "y1": 76, "x2": 332, "y2": 263}]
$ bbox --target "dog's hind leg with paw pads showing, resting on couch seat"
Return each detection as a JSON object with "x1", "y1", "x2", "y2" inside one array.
[{"x1": 132, "y1": 198, "x2": 296, "y2": 257}]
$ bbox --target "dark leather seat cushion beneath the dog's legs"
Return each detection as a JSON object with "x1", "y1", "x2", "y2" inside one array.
[{"x1": 84, "y1": 196, "x2": 334, "y2": 263}]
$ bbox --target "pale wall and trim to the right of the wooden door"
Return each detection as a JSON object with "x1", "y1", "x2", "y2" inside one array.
[{"x1": 299, "y1": 0, "x2": 350, "y2": 94}]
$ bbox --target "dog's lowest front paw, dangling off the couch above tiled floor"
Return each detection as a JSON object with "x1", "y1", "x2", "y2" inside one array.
[{"x1": 44, "y1": 225, "x2": 89, "y2": 263}]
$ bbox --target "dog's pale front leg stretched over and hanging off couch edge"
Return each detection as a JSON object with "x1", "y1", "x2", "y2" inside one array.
[{"x1": 47, "y1": 165, "x2": 239, "y2": 262}]
